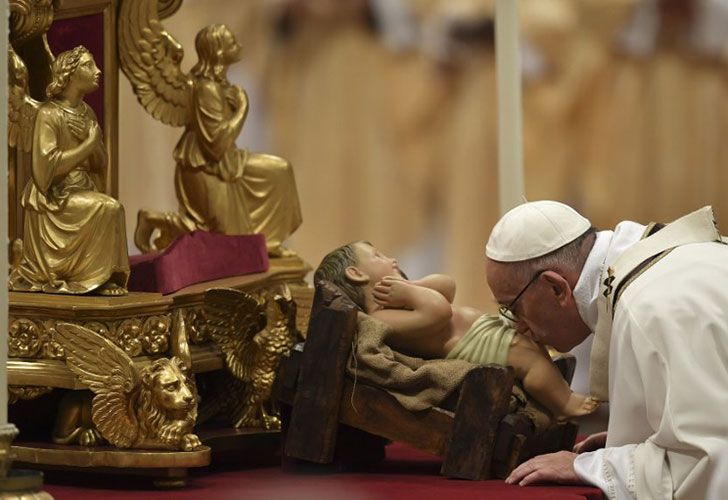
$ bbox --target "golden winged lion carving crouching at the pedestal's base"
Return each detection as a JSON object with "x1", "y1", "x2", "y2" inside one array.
[{"x1": 54, "y1": 323, "x2": 201, "y2": 451}]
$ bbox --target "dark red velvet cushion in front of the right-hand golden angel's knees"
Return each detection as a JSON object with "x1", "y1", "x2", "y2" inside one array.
[{"x1": 128, "y1": 231, "x2": 268, "y2": 294}]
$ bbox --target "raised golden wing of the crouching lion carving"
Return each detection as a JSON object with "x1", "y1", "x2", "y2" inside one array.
[{"x1": 55, "y1": 323, "x2": 139, "y2": 448}]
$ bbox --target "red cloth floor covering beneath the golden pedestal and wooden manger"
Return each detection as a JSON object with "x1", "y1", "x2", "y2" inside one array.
[{"x1": 44, "y1": 444, "x2": 604, "y2": 500}]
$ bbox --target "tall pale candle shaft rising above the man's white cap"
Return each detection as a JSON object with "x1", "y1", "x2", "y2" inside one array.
[{"x1": 495, "y1": 0, "x2": 524, "y2": 215}]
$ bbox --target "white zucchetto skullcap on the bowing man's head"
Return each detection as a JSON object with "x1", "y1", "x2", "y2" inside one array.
[{"x1": 485, "y1": 200, "x2": 591, "y2": 262}]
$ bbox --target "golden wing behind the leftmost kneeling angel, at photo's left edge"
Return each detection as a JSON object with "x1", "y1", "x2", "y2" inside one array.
[{"x1": 8, "y1": 46, "x2": 40, "y2": 152}]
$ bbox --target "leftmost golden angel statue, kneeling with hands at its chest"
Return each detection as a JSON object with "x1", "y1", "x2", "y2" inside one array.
[{"x1": 9, "y1": 46, "x2": 129, "y2": 295}]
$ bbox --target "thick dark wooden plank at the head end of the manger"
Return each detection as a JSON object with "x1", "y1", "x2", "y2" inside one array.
[{"x1": 285, "y1": 286, "x2": 357, "y2": 463}]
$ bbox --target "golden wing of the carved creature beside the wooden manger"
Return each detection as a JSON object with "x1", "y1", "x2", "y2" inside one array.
[{"x1": 204, "y1": 288, "x2": 267, "y2": 381}]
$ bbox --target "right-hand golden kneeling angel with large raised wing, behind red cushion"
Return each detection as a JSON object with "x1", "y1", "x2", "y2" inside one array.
[{"x1": 119, "y1": 0, "x2": 301, "y2": 256}]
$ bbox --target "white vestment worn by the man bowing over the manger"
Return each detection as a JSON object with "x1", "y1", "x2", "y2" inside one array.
[{"x1": 574, "y1": 206, "x2": 728, "y2": 500}]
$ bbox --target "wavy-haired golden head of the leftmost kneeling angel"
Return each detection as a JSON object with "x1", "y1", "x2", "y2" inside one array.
[{"x1": 46, "y1": 45, "x2": 101, "y2": 98}]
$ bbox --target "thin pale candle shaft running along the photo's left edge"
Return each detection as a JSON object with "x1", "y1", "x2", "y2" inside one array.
[{"x1": 0, "y1": 0, "x2": 9, "y2": 426}]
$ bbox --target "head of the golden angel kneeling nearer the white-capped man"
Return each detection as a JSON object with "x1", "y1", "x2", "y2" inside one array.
[{"x1": 192, "y1": 24, "x2": 241, "y2": 80}]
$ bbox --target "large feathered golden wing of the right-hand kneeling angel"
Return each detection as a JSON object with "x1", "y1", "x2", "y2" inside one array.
[{"x1": 118, "y1": 0, "x2": 192, "y2": 127}]
